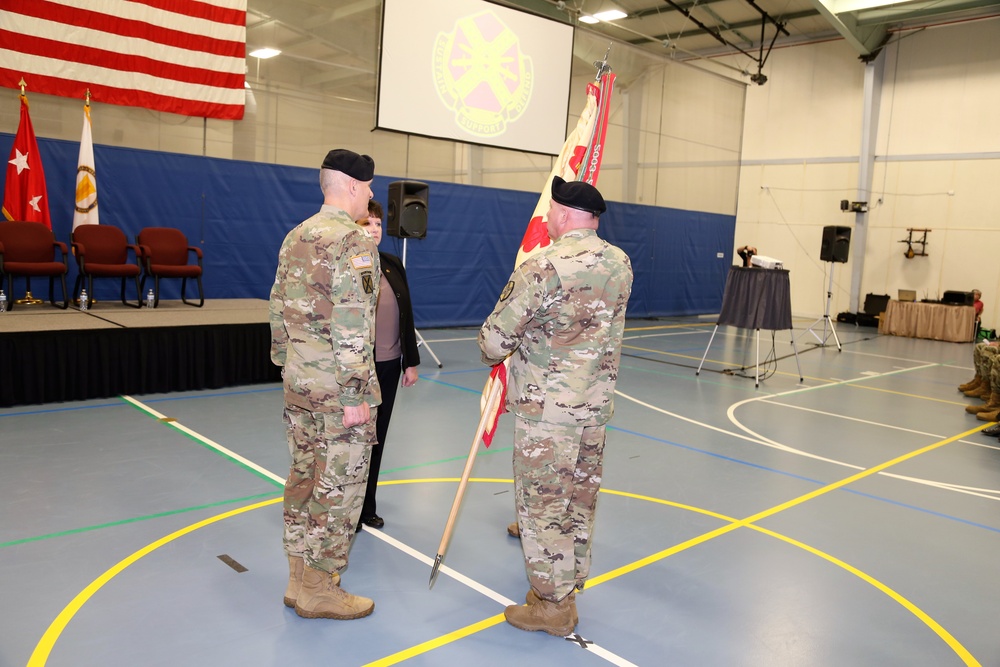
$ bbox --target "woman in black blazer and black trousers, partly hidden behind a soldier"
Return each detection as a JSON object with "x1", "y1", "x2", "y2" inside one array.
[{"x1": 358, "y1": 200, "x2": 420, "y2": 529}]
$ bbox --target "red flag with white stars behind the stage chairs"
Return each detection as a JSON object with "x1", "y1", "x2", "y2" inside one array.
[{"x1": 3, "y1": 94, "x2": 52, "y2": 229}]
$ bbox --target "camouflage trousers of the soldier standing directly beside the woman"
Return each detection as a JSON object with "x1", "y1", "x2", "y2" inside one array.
[{"x1": 284, "y1": 405, "x2": 376, "y2": 572}]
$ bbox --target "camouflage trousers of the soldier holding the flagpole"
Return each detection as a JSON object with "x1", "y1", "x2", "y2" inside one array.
[{"x1": 514, "y1": 418, "x2": 605, "y2": 602}]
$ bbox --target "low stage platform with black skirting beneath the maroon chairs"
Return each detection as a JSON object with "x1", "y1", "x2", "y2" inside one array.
[{"x1": 0, "y1": 299, "x2": 281, "y2": 407}]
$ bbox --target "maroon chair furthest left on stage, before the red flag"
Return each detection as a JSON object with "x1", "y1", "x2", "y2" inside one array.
[{"x1": 0, "y1": 221, "x2": 69, "y2": 310}]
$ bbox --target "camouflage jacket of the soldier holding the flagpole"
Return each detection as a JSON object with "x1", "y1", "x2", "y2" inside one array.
[{"x1": 479, "y1": 229, "x2": 632, "y2": 426}]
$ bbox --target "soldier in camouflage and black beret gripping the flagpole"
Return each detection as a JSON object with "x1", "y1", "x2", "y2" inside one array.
[{"x1": 479, "y1": 176, "x2": 632, "y2": 636}]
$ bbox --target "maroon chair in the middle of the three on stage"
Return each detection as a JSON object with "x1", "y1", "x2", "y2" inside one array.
[{"x1": 72, "y1": 225, "x2": 142, "y2": 308}]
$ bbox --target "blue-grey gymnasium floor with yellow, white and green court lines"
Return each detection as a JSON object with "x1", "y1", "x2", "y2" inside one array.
[{"x1": 0, "y1": 318, "x2": 1000, "y2": 667}]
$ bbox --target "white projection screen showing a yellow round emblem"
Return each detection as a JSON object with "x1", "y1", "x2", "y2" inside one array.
[{"x1": 375, "y1": 0, "x2": 573, "y2": 155}]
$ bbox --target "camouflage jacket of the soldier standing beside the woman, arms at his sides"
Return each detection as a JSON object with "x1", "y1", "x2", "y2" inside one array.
[{"x1": 270, "y1": 205, "x2": 381, "y2": 412}]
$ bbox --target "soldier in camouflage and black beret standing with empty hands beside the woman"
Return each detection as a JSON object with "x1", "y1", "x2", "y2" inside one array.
[{"x1": 270, "y1": 149, "x2": 381, "y2": 619}]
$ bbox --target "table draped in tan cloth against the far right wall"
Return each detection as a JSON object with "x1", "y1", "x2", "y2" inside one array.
[{"x1": 878, "y1": 299, "x2": 976, "y2": 343}]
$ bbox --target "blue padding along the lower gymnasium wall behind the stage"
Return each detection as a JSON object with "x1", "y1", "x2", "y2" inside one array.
[{"x1": 0, "y1": 133, "x2": 736, "y2": 328}]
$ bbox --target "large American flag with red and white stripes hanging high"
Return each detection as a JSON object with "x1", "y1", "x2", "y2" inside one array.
[{"x1": 0, "y1": 0, "x2": 247, "y2": 120}]
